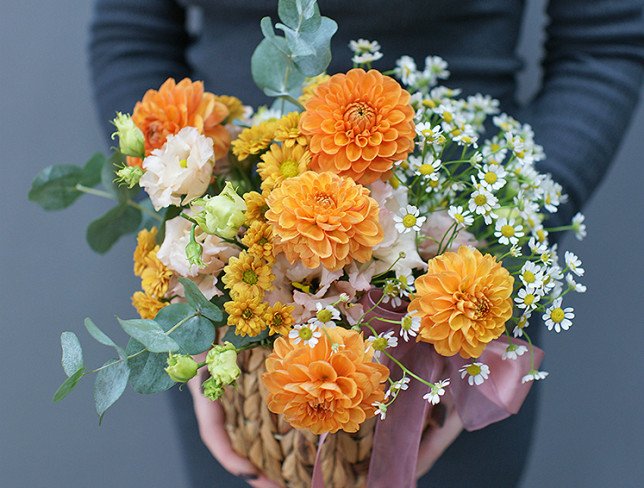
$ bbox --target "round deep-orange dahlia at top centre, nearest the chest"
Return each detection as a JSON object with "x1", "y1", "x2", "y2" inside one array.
[{"x1": 300, "y1": 69, "x2": 416, "y2": 184}]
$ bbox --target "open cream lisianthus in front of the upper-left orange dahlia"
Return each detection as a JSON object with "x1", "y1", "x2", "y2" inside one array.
[{"x1": 139, "y1": 127, "x2": 215, "y2": 210}]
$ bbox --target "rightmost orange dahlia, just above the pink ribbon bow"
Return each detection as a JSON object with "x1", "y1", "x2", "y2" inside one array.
[{"x1": 409, "y1": 246, "x2": 514, "y2": 358}]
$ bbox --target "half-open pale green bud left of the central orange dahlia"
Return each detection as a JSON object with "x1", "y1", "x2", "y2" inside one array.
[{"x1": 194, "y1": 181, "x2": 246, "y2": 239}]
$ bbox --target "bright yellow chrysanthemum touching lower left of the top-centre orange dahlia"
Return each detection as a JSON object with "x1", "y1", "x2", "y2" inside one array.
[{"x1": 257, "y1": 144, "x2": 311, "y2": 195}]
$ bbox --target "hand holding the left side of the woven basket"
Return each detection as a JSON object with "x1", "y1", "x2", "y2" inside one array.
[{"x1": 188, "y1": 359, "x2": 279, "y2": 488}]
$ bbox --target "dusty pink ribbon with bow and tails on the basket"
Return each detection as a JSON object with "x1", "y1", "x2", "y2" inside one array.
[{"x1": 312, "y1": 289, "x2": 543, "y2": 488}]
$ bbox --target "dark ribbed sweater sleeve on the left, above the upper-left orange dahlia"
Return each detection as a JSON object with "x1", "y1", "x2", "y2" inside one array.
[{"x1": 89, "y1": 0, "x2": 190, "y2": 134}]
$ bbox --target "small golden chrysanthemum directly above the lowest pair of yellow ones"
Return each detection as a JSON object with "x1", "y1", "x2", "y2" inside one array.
[{"x1": 222, "y1": 251, "x2": 275, "y2": 298}]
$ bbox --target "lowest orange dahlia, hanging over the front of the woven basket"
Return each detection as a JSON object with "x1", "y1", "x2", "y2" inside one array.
[{"x1": 262, "y1": 327, "x2": 389, "y2": 434}]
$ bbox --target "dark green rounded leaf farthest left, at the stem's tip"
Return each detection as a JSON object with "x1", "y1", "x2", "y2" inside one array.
[{"x1": 29, "y1": 164, "x2": 83, "y2": 210}]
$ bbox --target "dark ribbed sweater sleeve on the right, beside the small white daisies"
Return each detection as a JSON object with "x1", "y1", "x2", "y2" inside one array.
[{"x1": 523, "y1": 0, "x2": 644, "y2": 224}]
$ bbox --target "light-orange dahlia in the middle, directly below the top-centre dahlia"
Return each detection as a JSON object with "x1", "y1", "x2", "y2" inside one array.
[{"x1": 266, "y1": 171, "x2": 383, "y2": 271}]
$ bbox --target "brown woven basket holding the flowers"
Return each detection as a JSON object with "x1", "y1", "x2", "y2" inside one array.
[{"x1": 221, "y1": 348, "x2": 375, "y2": 488}]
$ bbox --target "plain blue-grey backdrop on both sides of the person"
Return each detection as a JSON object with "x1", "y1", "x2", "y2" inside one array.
[{"x1": 0, "y1": 0, "x2": 644, "y2": 488}]
